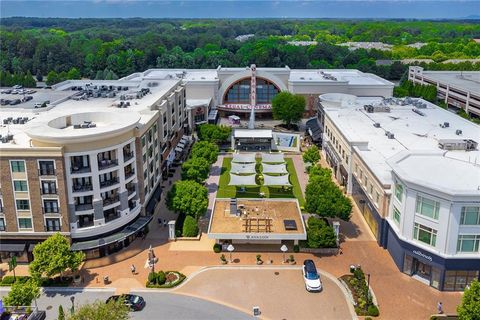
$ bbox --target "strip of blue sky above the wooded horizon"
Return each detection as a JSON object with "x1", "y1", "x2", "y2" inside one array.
[{"x1": 0, "y1": 0, "x2": 480, "y2": 19}]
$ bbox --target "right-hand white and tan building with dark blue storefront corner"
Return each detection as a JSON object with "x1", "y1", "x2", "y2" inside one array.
[{"x1": 319, "y1": 94, "x2": 480, "y2": 291}]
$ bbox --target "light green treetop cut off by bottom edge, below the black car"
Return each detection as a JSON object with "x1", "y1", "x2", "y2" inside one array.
[{"x1": 67, "y1": 299, "x2": 130, "y2": 320}]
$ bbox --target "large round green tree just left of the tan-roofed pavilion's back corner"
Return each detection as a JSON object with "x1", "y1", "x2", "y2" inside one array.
[{"x1": 167, "y1": 180, "x2": 208, "y2": 218}]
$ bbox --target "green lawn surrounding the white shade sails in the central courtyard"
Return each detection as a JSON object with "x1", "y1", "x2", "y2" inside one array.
[{"x1": 217, "y1": 158, "x2": 305, "y2": 206}]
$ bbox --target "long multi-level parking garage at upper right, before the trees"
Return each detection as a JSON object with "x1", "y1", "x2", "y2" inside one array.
[{"x1": 408, "y1": 66, "x2": 480, "y2": 117}]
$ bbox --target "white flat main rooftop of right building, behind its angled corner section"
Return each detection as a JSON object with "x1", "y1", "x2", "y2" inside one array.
[{"x1": 324, "y1": 98, "x2": 480, "y2": 189}]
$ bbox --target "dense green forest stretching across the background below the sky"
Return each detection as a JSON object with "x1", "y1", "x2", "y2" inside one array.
[{"x1": 0, "y1": 18, "x2": 480, "y2": 83}]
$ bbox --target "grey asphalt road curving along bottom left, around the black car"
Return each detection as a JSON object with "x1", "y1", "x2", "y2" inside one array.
[{"x1": 0, "y1": 288, "x2": 252, "y2": 320}]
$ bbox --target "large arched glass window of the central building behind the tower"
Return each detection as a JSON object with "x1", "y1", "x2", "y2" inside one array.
[{"x1": 224, "y1": 78, "x2": 280, "y2": 104}]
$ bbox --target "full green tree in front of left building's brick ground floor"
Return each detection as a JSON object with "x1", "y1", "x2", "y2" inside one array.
[{"x1": 30, "y1": 233, "x2": 85, "y2": 278}]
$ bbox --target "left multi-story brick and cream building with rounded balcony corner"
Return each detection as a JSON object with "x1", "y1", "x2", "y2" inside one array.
[{"x1": 0, "y1": 79, "x2": 188, "y2": 261}]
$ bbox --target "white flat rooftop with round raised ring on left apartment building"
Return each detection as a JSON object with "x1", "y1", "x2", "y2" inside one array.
[{"x1": 0, "y1": 79, "x2": 179, "y2": 149}]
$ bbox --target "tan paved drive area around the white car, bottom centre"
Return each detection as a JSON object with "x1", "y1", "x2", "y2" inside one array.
[{"x1": 175, "y1": 266, "x2": 356, "y2": 320}]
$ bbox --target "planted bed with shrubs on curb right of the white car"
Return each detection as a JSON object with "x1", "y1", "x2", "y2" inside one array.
[{"x1": 340, "y1": 267, "x2": 380, "y2": 317}]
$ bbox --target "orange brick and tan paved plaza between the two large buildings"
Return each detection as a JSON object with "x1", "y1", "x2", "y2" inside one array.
[{"x1": 1, "y1": 155, "x2": 461, "y2": 320}]
